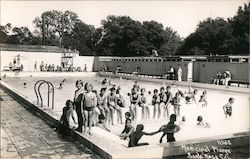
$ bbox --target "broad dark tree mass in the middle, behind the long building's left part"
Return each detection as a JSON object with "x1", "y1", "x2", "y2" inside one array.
[{"x1": 97, "y1": 16, "x2": 180, "y2": 56}]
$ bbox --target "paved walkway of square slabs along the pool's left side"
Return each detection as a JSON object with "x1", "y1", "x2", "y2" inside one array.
[{"x1": 0, "y1": 90, "x2": 100, "y2": 159}]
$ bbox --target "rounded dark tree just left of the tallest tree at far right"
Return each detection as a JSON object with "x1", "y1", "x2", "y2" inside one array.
[{"x1": 180, "y1": 18, "x2": 232, "y2": 54}]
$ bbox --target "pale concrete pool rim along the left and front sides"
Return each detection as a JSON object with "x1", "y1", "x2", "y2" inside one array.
[{"x1": 1, "y1": 74, "x2": 249, "y2": 159}]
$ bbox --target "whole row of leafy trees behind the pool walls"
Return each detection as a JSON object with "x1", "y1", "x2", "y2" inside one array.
[{"x1": 0, "y1": 3, "x2": 250, "y2": 56}]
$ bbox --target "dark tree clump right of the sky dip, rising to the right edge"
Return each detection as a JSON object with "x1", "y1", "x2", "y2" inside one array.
[{"x1": 179, "y1": 3, "x2": 250, "y2": 55}]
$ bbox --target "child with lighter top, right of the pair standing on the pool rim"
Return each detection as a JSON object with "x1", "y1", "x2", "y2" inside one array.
[{"x1": 83, "y1": 83, "x2": 97, "y2": 135}]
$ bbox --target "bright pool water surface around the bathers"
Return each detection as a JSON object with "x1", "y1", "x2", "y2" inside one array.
[{"x1": 4, "y1": 73, "x2": 249, "y2": 146}]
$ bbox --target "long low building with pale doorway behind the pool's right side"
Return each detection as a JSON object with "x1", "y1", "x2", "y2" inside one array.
[{"x1": 94, "y1": 56, "x2": 250, "y2": 83}]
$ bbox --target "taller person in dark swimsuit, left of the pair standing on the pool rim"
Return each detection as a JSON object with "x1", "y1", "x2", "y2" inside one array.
[{"x1": 74, "y1": 80, "x2": 84, "y2": 132}]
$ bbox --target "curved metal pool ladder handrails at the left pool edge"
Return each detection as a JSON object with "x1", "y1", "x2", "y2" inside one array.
[{"x1": 34, "y1": 80, "x2": 55, "y2": 109}]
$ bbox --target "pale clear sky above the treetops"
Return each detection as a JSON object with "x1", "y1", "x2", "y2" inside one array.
[{"x1": 0, "y1": 0, "x2": 248, "y2": 38}]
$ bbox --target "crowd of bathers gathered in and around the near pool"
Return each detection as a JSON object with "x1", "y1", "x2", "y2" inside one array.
[{"x1": 53, "y1": 78, "x2": 234, "y2": 147}]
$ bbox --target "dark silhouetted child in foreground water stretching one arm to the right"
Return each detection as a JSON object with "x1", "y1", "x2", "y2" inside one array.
[{"x1": 128, "y1": 124, "x2": 160, "y2": 147}]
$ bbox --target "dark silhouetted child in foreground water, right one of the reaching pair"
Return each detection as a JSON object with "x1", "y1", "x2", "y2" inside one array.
[{"x1": 159, "y1": 114, "x2": 181, "y2": 143}]
